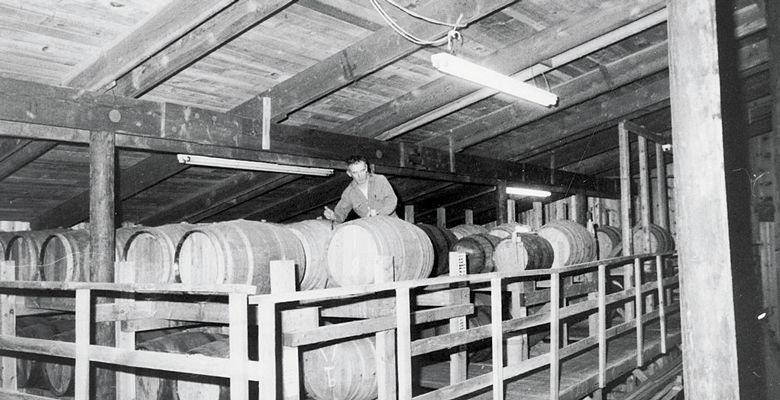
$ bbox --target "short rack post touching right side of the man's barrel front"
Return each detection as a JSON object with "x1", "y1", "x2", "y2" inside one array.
[{"x1": 374, "y1": 256, "x2": 396, "y2": 400}]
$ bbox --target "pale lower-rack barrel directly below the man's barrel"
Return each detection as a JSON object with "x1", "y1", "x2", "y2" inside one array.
[{"x1": 303, "y1": 338, "x2": 378, "y2": 400}]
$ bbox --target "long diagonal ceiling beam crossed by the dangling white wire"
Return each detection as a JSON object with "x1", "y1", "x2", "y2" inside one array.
[{"x1": 231, "y1": 0, "x2": 514, "y2": 121}]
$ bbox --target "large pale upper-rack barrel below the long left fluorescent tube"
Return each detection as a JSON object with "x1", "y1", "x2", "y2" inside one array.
[{"x1": 176, "y1": 220, "x2": 306, "y2": 293}]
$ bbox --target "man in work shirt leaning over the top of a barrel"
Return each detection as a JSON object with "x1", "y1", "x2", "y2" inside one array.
[{"x1": 323, "y1": 156, "x2": 398, "y2": 222}]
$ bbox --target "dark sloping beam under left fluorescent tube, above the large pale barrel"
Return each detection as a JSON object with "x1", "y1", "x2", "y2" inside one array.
[{"x1": 139, "y1": 171, "x2": 301, "y2": 226}]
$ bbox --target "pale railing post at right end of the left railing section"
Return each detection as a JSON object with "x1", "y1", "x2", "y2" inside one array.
[{"x1": 228, "y1": 293, "x2": 249, "y2": 400}]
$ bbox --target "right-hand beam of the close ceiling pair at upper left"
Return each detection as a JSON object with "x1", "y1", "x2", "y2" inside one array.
[{"x1": 112, "y1": 0, "x2": 293, "y2": 97}]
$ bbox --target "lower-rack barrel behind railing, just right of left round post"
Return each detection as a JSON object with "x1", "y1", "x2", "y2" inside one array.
[{"x1": 136, "y1": 331, "x2": 221, "y2": 400}]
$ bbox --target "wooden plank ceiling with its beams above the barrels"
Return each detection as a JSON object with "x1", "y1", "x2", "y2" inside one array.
[{"x1": 0, "y1": 0, "x2": 769, "y2": 227}]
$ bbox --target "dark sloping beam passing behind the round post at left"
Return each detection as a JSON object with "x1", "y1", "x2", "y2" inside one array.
[{"x1": 30, "y1": 154, "x2": 189, "y2": 229}]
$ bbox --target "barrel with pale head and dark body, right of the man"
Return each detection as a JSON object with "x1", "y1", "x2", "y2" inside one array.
[{"x1": 493, "y1": 233, "x2": 554, "y2": 272}]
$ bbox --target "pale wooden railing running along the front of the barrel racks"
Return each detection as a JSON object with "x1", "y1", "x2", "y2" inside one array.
[{"x1": 0, "y1": 250, "x2": 679, "y2": 400}]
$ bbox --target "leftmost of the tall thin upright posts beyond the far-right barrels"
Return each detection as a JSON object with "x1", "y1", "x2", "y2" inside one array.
[{"x1": 618, "y1": 122, "x2": 634, "y2": 321}]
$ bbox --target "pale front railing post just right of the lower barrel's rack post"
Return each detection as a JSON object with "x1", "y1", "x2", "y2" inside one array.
[{"x1": 396, "y1": 287, "x2": 412, "y2": 400}]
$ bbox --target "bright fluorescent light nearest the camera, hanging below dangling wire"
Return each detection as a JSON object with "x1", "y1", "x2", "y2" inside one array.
[{"x1": 431, "y1": 53, "x2": 558, "y2": 107}]
